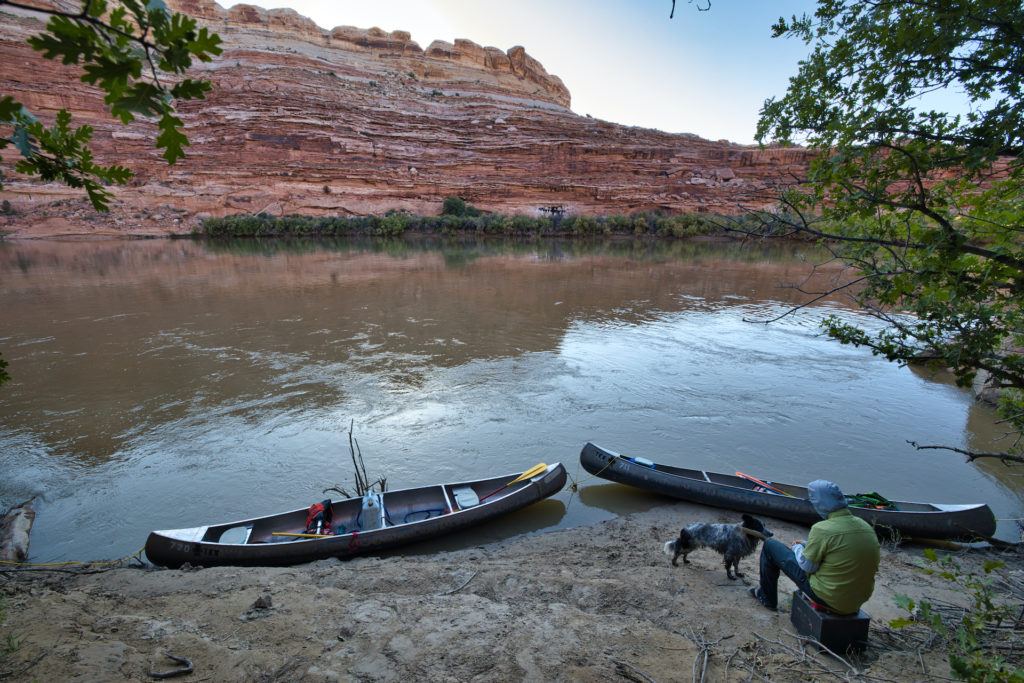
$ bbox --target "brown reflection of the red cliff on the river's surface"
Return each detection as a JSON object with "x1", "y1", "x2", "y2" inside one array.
[{"x1": 0, "y1": 236, "x2": 839, "y2": 463}]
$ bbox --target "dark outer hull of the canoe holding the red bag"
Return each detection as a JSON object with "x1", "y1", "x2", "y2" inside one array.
[{"x1": 145, "y1": 464, "x2": 566, "y2": 568}]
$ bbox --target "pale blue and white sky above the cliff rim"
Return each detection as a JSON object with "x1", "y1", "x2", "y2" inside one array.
[{"x1": 228, "y1": 0, "x2": 815, "y2": 143}]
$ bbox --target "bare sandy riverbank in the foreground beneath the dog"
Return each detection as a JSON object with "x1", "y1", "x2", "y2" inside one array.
[{"x1": 0, "y1": 504, "x2": 1022, "y2": 682}]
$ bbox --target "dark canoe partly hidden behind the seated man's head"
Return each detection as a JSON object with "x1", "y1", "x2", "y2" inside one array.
[{"x1": 580, "y1": 443, "x2": 995, "y2": 541}]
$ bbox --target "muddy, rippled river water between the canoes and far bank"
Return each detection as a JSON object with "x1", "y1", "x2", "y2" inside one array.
[{"x1": 0, "y1": 236, "x2": 1024, "y2": 561}]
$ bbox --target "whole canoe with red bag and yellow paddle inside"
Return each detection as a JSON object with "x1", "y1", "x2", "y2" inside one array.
[{"x1": 145, "y1": 463, "x2": 565, "y2": 568}]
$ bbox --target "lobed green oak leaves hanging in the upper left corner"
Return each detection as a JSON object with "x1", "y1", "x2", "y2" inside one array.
[{"x1": 0, "y1": 0, "x2": 221, "y2": 211}]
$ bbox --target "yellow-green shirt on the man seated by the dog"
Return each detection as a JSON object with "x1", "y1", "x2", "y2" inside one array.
[{"x1": 804, "y1": 508, "x2": 879, "y2": 614}]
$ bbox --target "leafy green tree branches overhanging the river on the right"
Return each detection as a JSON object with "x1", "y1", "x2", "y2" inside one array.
[{"x1": 758, "y1": 0, "x2": 1024, "y2": 447}]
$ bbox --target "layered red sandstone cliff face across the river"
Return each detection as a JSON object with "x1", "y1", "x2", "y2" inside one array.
[{"x1": 0, "y1": 0, "x2": 807, "y2": 237}]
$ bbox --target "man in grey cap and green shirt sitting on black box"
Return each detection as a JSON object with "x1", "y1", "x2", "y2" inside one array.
[{"x1": 750, "y1": 479, "x2": 879, "y2": 614}]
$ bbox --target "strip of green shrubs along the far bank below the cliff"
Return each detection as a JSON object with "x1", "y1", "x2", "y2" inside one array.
[{"x1": 196, "y1": 204, "x2": 722, "y2": 238}]
